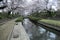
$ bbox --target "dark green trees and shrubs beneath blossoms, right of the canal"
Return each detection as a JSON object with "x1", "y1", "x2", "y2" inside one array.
[{"x1": 30, "y1": 10, "x2": 58, "y2": 18}]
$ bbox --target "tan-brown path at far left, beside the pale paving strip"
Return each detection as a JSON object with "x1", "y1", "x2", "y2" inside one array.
[{"x1": 0, "y1": 19, "x2": 16, "y2": 40}]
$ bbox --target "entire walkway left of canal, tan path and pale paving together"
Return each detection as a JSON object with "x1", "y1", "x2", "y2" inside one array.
[{"x1": 0, "y1": 19, "x2": 29, "y2": 40}]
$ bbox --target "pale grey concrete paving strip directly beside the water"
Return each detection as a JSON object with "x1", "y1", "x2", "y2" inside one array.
[{"x1": 10, "y1": 22, "x2": 30, "y2": 40}]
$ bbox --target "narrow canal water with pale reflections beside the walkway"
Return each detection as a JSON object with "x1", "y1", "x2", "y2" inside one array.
[{"x1": 23, "y1": 18, "x2": 60, "y2": 40}]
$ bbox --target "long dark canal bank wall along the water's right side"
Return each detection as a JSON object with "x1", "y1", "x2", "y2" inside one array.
[{"x1": 29, "y1": 18, "x2": 60, "y2": 32}]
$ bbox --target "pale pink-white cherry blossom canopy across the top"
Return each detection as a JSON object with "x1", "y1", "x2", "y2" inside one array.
[{"x1": 0, "y1": 0, "x2": 58, "y2": 14}]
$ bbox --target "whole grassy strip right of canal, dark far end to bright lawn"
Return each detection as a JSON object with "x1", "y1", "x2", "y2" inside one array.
[{"x1": 29, "y1": 16, "x2": 60, "y2": 26}]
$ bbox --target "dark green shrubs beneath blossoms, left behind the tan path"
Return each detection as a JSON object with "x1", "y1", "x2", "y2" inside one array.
[{"x1": 0, "y1": 12, "x2": 20, "y2": 19}]
